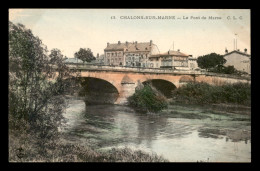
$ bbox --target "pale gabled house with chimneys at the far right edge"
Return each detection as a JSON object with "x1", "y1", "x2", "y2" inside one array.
[{"x1": 223, "y1": 49, "x2": 251, "y2": 74}]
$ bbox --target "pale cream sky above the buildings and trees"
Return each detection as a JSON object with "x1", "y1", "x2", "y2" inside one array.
[{"x1": 9, "y1": 9, "x2": 251, "y2": 58}]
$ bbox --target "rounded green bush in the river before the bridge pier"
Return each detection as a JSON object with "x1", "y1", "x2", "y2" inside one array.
[{"x1": 128, "y1": 85, "x2": 168, "y2": 112}]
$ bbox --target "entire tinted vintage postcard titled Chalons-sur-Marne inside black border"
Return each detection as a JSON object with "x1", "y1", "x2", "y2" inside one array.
[{"x1": 8, "y1": 8, "x2": 251, "y2": 163}]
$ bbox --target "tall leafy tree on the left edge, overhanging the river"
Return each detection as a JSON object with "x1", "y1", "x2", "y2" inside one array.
[{"x1": 8, "y1": 22, "x2": 78, "y2": 150}]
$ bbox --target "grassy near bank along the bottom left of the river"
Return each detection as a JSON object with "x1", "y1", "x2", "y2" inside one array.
[{"x1": 9, "y1": 134, "x2": 167, "y2": 162}]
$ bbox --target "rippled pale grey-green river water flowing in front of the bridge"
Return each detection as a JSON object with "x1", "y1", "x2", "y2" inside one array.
[{"x1": 62, "y1": 99, "x2": 251, "y2": 162}]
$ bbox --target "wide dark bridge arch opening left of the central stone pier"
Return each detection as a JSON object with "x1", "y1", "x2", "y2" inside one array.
[{"x1": 78, "y1": 77, "x2": 119, "y2": 104}]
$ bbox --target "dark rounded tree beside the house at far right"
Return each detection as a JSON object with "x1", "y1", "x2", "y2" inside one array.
[{"x1": 197, "y1": 53, "x2": 226, "y2": 70}]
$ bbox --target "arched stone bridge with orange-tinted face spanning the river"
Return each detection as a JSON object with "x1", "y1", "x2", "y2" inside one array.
[{"x1": 64, "y1": 65, "x2": 251, "y2": 104}]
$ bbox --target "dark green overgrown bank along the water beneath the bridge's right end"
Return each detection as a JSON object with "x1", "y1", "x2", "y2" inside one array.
[{"x1": 171, "y1": 83, "x2": 251, "y2": 106}]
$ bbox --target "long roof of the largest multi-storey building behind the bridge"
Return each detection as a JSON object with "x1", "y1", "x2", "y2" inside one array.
[{"x1": 104, "y1": 42, "x2": 153, "y2": 52}]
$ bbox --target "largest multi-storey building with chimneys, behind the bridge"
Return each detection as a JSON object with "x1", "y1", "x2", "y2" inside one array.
[{"x1": 104, "y1": 40, "x2": 158, "y2": 67}]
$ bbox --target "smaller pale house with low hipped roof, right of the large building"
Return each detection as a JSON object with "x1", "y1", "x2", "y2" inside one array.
[{"x1": 149, "y1": 50, "x2": 189, "y2": 69}]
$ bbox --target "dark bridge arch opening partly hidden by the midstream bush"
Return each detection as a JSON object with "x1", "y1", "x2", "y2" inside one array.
[{"x1": 143, "y1": 79, "x2": 177, "y2": 98}]
